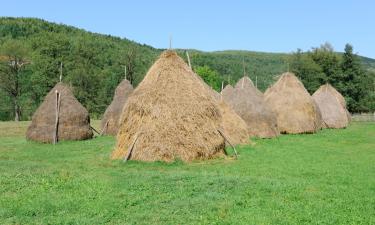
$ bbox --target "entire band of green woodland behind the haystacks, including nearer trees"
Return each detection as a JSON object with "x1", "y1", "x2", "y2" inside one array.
[{"x1": 0, "y1": 17, "x2": 375, "y2": 120}]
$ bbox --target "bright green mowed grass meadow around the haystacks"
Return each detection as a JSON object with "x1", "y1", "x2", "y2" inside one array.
[{"x1": 0, "y1": 122, "x2": 375, "y2": 224}]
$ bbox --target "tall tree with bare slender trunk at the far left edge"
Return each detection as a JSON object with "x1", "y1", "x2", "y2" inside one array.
[{"x1": 0, "y1": 40, "x2": 29, "y2": 121}]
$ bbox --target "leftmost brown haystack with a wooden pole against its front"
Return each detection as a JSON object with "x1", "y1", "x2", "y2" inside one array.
[{"x1": 26, "y1": 82, "x2": 93, "y2": 143}]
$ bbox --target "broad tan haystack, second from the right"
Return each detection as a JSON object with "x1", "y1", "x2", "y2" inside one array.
[{"x1": 264, "y1": 72, "x2": 322, "y2": 134}]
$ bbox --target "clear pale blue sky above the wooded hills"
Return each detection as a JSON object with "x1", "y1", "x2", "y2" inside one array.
[{"x1": 0, "y1": 0, "x2": 375, "y2": 58}]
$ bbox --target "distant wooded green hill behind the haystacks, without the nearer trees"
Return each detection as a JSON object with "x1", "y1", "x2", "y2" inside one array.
[{"x1": 0, "y1": 18, "x2": 375, "y2": 120}]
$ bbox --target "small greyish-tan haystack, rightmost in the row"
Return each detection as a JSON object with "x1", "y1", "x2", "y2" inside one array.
[{"x1": 312, "y1": 84, "x2": 350, "y2": 128}]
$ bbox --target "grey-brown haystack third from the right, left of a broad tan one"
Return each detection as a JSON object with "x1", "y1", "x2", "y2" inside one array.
[{"x1": 223, "y1": 77, "x2": 280, "y2": 138}]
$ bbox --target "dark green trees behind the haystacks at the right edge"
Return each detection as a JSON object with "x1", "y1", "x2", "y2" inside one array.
[{"x1": 290, "y1": 43, "x2": 375, "y2": 112}]
